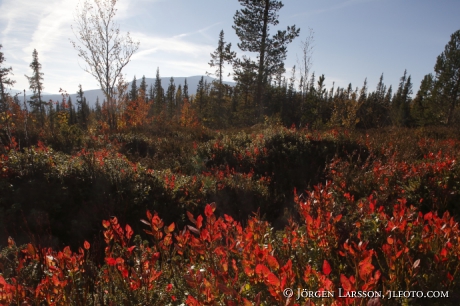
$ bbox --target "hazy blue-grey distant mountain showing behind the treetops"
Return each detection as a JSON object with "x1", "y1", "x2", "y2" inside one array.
[{"x1": 10, "y1": 75, "x2": 235, "y2": 108}]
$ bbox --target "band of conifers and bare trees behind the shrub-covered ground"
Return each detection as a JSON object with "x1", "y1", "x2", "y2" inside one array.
[{"x1": 0, "y1": 0, "x2": 460, "y2": 147}]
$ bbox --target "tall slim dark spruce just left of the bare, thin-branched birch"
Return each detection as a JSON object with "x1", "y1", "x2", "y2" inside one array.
[{"x1": 26, "y1": 49, "x2": 46, "y2": 127}]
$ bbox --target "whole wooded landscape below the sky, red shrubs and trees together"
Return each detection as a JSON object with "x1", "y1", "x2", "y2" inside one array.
[{"x1": 0, "y1": 0, "x2": 460, "y2": 306}]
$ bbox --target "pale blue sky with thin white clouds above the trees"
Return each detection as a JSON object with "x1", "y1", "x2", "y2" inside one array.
[{"x1": 0, "y1": 0, "x2": 460, "y2": 94}]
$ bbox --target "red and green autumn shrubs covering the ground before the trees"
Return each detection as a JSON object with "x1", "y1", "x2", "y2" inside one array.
[{"x1": 0, "y1": 127, "x2": 460, "y2": 305}]
